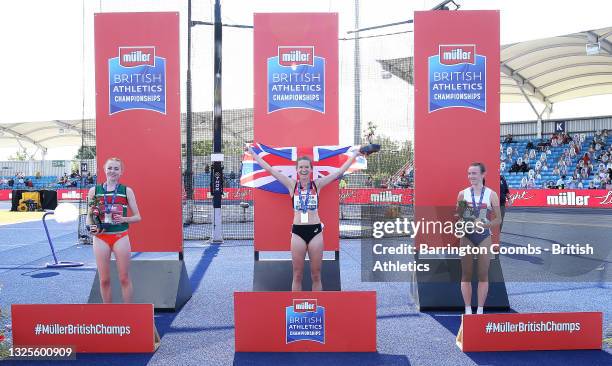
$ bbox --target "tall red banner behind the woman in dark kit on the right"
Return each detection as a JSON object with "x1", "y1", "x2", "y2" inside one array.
[{"x1": 414, "y1": 11, "x2": 500, "y2": 245}]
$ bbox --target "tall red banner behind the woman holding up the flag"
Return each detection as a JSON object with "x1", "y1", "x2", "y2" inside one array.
[{"x1": 254, "y1": 13, "x2": 339, "y2": 251}]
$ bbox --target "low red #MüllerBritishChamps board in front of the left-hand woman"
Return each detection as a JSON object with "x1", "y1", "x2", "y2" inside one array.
[{"x1": 11, "y1": 304, "x2": 159, "y2": 353}]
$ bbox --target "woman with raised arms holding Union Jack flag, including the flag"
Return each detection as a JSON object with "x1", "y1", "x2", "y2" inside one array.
[{"x1": 241, "y1": 144, "x2": 363, "y2": 291}]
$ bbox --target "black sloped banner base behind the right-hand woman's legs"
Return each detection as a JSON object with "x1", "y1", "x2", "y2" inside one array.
[{"x1": 411, "y1": 258, "x2": 510, "y2": 311}]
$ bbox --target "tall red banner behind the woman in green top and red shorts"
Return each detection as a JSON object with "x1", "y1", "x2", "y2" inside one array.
[{"x1": 95, "y1": 12, "x2": 183, "y2": 252}]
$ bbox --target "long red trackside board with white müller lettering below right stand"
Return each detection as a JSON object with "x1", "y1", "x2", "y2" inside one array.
[{"x1": 508, "y1": 189, "x2": 612, "y2": 208}]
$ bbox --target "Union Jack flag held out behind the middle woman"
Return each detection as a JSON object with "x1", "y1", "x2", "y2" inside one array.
[{"x1": 240, "y1": 143, "x2": 367, "y2": 193}]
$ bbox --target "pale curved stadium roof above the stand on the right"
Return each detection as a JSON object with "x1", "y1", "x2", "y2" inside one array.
[{"x1": 379, "y1": 27, "x2": 612, "y2": 104}]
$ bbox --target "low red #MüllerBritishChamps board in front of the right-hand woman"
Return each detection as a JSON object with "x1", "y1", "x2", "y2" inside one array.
[{"x1": 457, "y1": 312, "x2": 603, "y2": 352}]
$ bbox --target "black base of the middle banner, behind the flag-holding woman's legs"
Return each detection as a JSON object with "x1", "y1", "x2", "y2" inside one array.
[{"x1": 253, "y1": 252, "x2": 341, "y2": 291}]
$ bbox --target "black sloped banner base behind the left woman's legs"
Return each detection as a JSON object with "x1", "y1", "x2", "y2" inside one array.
[{"x1": 89, "y1": 260, "x2": 193, "y2": 311}]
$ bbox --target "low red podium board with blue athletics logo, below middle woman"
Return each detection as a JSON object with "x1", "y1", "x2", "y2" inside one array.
[{"x1": 234, "y1": 291, "x2": 376, "y2": 352}]
